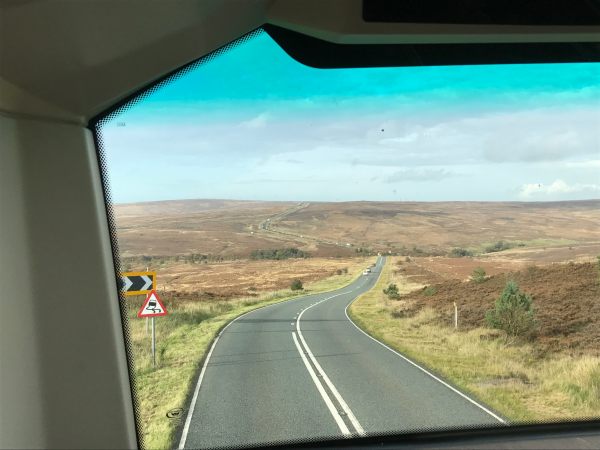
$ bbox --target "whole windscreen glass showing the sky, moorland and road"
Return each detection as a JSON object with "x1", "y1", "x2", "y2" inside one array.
[{"x1": 97, "y1": 32, "x2": 600, "y2": 448}]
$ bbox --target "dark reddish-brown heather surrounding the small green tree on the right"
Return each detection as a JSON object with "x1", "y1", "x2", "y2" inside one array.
[{"x1": 394, "y1": 261, "x2": 600, "y2": 356}]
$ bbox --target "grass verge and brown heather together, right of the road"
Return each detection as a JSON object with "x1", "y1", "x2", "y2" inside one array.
[{"x1": 350, "y1": 258, "x2": 600, "y2": 422}]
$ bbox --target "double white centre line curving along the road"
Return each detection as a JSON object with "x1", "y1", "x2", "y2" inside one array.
[{"x1": 292, "y1": 287, "x2": 365, "y2": 437}]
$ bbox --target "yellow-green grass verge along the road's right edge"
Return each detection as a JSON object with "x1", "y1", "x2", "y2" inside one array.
[{"x1": 348, "y1": 258, "x2": 600, "y2": 423}]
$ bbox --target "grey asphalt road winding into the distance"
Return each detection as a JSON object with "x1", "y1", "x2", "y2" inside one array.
[{"x1": 180, "y1": 258, "x2": 501, "y2": 448}]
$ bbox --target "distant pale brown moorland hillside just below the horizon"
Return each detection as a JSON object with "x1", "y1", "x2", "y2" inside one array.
[{"x1": 114, "y1": 200, "x2": 600, "y2": 261}]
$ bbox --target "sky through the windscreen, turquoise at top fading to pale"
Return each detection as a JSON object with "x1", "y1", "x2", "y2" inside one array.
[{"x1": 100, "y1": 29, "x2": 600, "y2": 203}]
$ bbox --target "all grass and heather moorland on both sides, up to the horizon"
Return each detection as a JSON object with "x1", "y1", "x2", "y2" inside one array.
[{"x1": 115, "y1": 200, "x2": 600, "y2": 448}]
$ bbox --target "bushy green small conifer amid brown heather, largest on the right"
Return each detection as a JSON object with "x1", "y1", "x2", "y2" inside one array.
[{"x1": 485, "y1": 281, "x2": 535, "y2": 340}]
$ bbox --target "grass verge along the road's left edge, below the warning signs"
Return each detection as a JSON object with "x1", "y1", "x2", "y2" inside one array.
[{"x1": 127, "y1": 258, "x2": 370, "y2": 449}]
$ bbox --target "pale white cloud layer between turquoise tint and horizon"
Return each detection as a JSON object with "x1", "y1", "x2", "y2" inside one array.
[{"x1": 103, "y1": 105, "x2": 600, "y2": 200}]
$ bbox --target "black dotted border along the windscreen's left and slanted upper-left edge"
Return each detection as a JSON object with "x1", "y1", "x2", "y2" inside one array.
[{"x1": 88, "y1": 28, "x2": 264, "y2": 449}]
